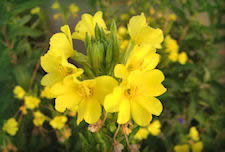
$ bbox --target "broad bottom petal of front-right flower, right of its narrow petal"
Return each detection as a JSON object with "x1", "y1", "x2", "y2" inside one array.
[{"x1": 131, "y1": 102, "x2": 152, "y2": 126}]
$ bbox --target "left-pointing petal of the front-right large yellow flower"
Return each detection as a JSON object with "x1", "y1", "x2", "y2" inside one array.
[{"x1": 104, "y1": 87, "x2": 122, "y2": 112}]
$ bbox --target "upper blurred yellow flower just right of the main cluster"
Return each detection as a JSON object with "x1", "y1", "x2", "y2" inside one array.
[{"x1": 165, "y1": 35, "x2": 179, "y2": 52}]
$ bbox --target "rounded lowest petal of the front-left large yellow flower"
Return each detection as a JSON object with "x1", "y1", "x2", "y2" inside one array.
[{"x1": 84, "y1": 98, "x2": 102, "y2": 124}]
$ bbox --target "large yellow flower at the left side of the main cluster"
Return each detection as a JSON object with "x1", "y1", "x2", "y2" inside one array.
[{"x1": 41, "y1": 25, "x2": 83, "y2": 87}]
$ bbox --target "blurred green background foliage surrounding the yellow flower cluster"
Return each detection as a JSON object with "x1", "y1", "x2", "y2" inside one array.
[{"x1": 0, "y1": 0, "x2": 225, "y2": 152}]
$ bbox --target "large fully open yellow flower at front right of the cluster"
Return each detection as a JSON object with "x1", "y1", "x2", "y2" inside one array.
[{"x1": 104, "y1": 69, "x2": 166, "y2": 126}]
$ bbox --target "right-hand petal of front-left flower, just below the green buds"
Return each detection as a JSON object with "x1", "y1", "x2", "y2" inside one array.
[{"x1": 95, "y1": 76, "x2": 118, "y2": 104}]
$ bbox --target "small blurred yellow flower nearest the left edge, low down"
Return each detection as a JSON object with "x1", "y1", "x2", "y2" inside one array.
[{"x1": 2, "y1": 118, "x2": 18, "y2": 136}]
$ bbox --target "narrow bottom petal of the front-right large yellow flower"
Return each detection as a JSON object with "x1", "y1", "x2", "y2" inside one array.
[{"x1": 117, "y1": 97, "x2": 130, "y2": 124}]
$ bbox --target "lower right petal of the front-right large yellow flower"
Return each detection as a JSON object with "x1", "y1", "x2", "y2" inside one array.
[{"x1": 137, "y1": 97, "x2": 163, "y2": 116}]
